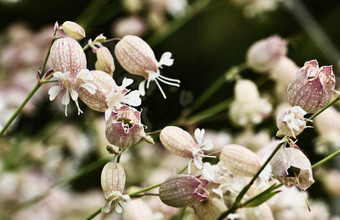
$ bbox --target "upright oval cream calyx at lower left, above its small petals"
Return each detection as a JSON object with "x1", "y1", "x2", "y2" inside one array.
[{"x1": 101, "y1": 161, "x2": 126, "y2": 199}]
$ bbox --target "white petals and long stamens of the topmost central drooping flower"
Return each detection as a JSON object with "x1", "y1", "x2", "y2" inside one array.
[{"x1": 138, "y1": 52, "x2": 180, "y2": 99}]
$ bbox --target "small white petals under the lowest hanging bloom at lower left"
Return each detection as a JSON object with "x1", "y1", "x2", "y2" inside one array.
[{"x1": 102, "y1": 191, "x2": 130, "y2": 213}]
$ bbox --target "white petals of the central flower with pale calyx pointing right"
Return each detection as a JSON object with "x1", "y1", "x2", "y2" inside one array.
[{"x1": 188, "y1": 128, "x2": 215, "y2": 174}]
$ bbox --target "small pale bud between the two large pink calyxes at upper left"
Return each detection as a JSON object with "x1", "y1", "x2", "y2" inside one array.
[{"x1": 96, "y1": 47, "x2": 115, "y2": 76}]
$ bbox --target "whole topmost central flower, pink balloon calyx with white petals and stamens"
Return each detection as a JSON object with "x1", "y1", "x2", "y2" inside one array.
[{"x1": 115, "y1": 35, "x2": 180, "y2": 98}]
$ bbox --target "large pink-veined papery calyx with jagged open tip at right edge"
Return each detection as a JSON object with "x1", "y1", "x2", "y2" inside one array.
[{"x1": 287, "y1": 60, "x2": 335, "y2": 113}]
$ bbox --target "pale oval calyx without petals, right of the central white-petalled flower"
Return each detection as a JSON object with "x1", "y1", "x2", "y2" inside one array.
[{"x1": 220, "y1": 144, "x2": 261, "y2": 176}]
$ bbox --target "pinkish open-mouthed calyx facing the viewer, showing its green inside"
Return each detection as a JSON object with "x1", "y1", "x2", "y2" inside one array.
[{"x1": 105, "y1": 105, "x2": 145, "y2": 149}]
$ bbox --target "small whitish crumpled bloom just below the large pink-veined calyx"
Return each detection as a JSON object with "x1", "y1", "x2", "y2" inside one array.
[{"x1": 276, "y1": 106, "x2": 307, "y2": 138}]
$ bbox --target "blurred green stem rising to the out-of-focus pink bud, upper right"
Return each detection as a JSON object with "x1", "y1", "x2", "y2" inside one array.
[{"x1": 190, "y1": 64, "x2": 247, "y2": 112}]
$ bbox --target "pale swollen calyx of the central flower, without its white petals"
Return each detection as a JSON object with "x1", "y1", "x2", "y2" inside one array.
[{"x1": 159, "y1": 126, "x2": 199, "y2": 158}]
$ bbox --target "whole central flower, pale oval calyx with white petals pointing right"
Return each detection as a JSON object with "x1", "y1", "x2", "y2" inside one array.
[{"x1": 160, "y1": 126, "x2": 213, "y2": 174}]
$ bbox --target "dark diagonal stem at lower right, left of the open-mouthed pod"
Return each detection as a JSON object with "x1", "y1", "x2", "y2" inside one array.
[{"x1": 218, "y1": 142, "x2": 285, "y2": 220}]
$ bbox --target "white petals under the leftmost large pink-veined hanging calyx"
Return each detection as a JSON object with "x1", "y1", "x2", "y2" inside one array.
[{"x1": 48, "y1": 69, "x2": 96, "y2": 116}]
